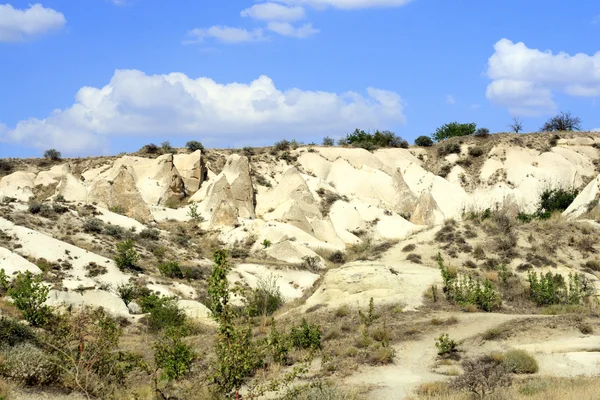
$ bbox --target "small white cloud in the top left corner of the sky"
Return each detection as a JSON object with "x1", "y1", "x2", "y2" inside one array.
[{"x1": 0, "y1": 4, "x2": 67, "y2": 42}]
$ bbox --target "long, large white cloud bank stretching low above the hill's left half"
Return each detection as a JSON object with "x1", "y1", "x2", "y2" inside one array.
[{"x1": 0, "y1": 70, "x2": 404, "y2": 154}]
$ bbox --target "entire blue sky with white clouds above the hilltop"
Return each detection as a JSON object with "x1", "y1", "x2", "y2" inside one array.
[{"x1": 0, "y1": 0, "x2": 600, "y2": 157}]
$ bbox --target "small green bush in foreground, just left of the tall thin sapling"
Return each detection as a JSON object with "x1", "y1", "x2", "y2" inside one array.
[{"x1": 153, "y1": 328, "x2": 194, "y2": 381}]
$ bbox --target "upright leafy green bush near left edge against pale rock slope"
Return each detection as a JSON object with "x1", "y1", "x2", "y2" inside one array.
[{"x1": 8, "y1": 271, "x2": 51, "y2": 326}]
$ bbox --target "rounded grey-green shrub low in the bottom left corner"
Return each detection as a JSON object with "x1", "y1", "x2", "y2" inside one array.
[{"x1": 0, "y1": 343, "x2": 61, "y2": 386}]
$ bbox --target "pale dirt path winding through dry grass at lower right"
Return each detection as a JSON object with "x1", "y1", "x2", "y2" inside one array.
[{"x1": 344, "y1": 313, "x2": 532, "y2": 400}]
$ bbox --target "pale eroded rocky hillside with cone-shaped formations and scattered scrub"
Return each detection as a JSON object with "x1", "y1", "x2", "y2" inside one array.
[{"x1": 0, "y1": 133, "x2": 600, "y2": 399}]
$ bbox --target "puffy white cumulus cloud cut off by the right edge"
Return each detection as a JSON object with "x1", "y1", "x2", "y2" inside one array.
[{"x1": 486, "y1": 39, "x2": 600, "y2": 115}]
